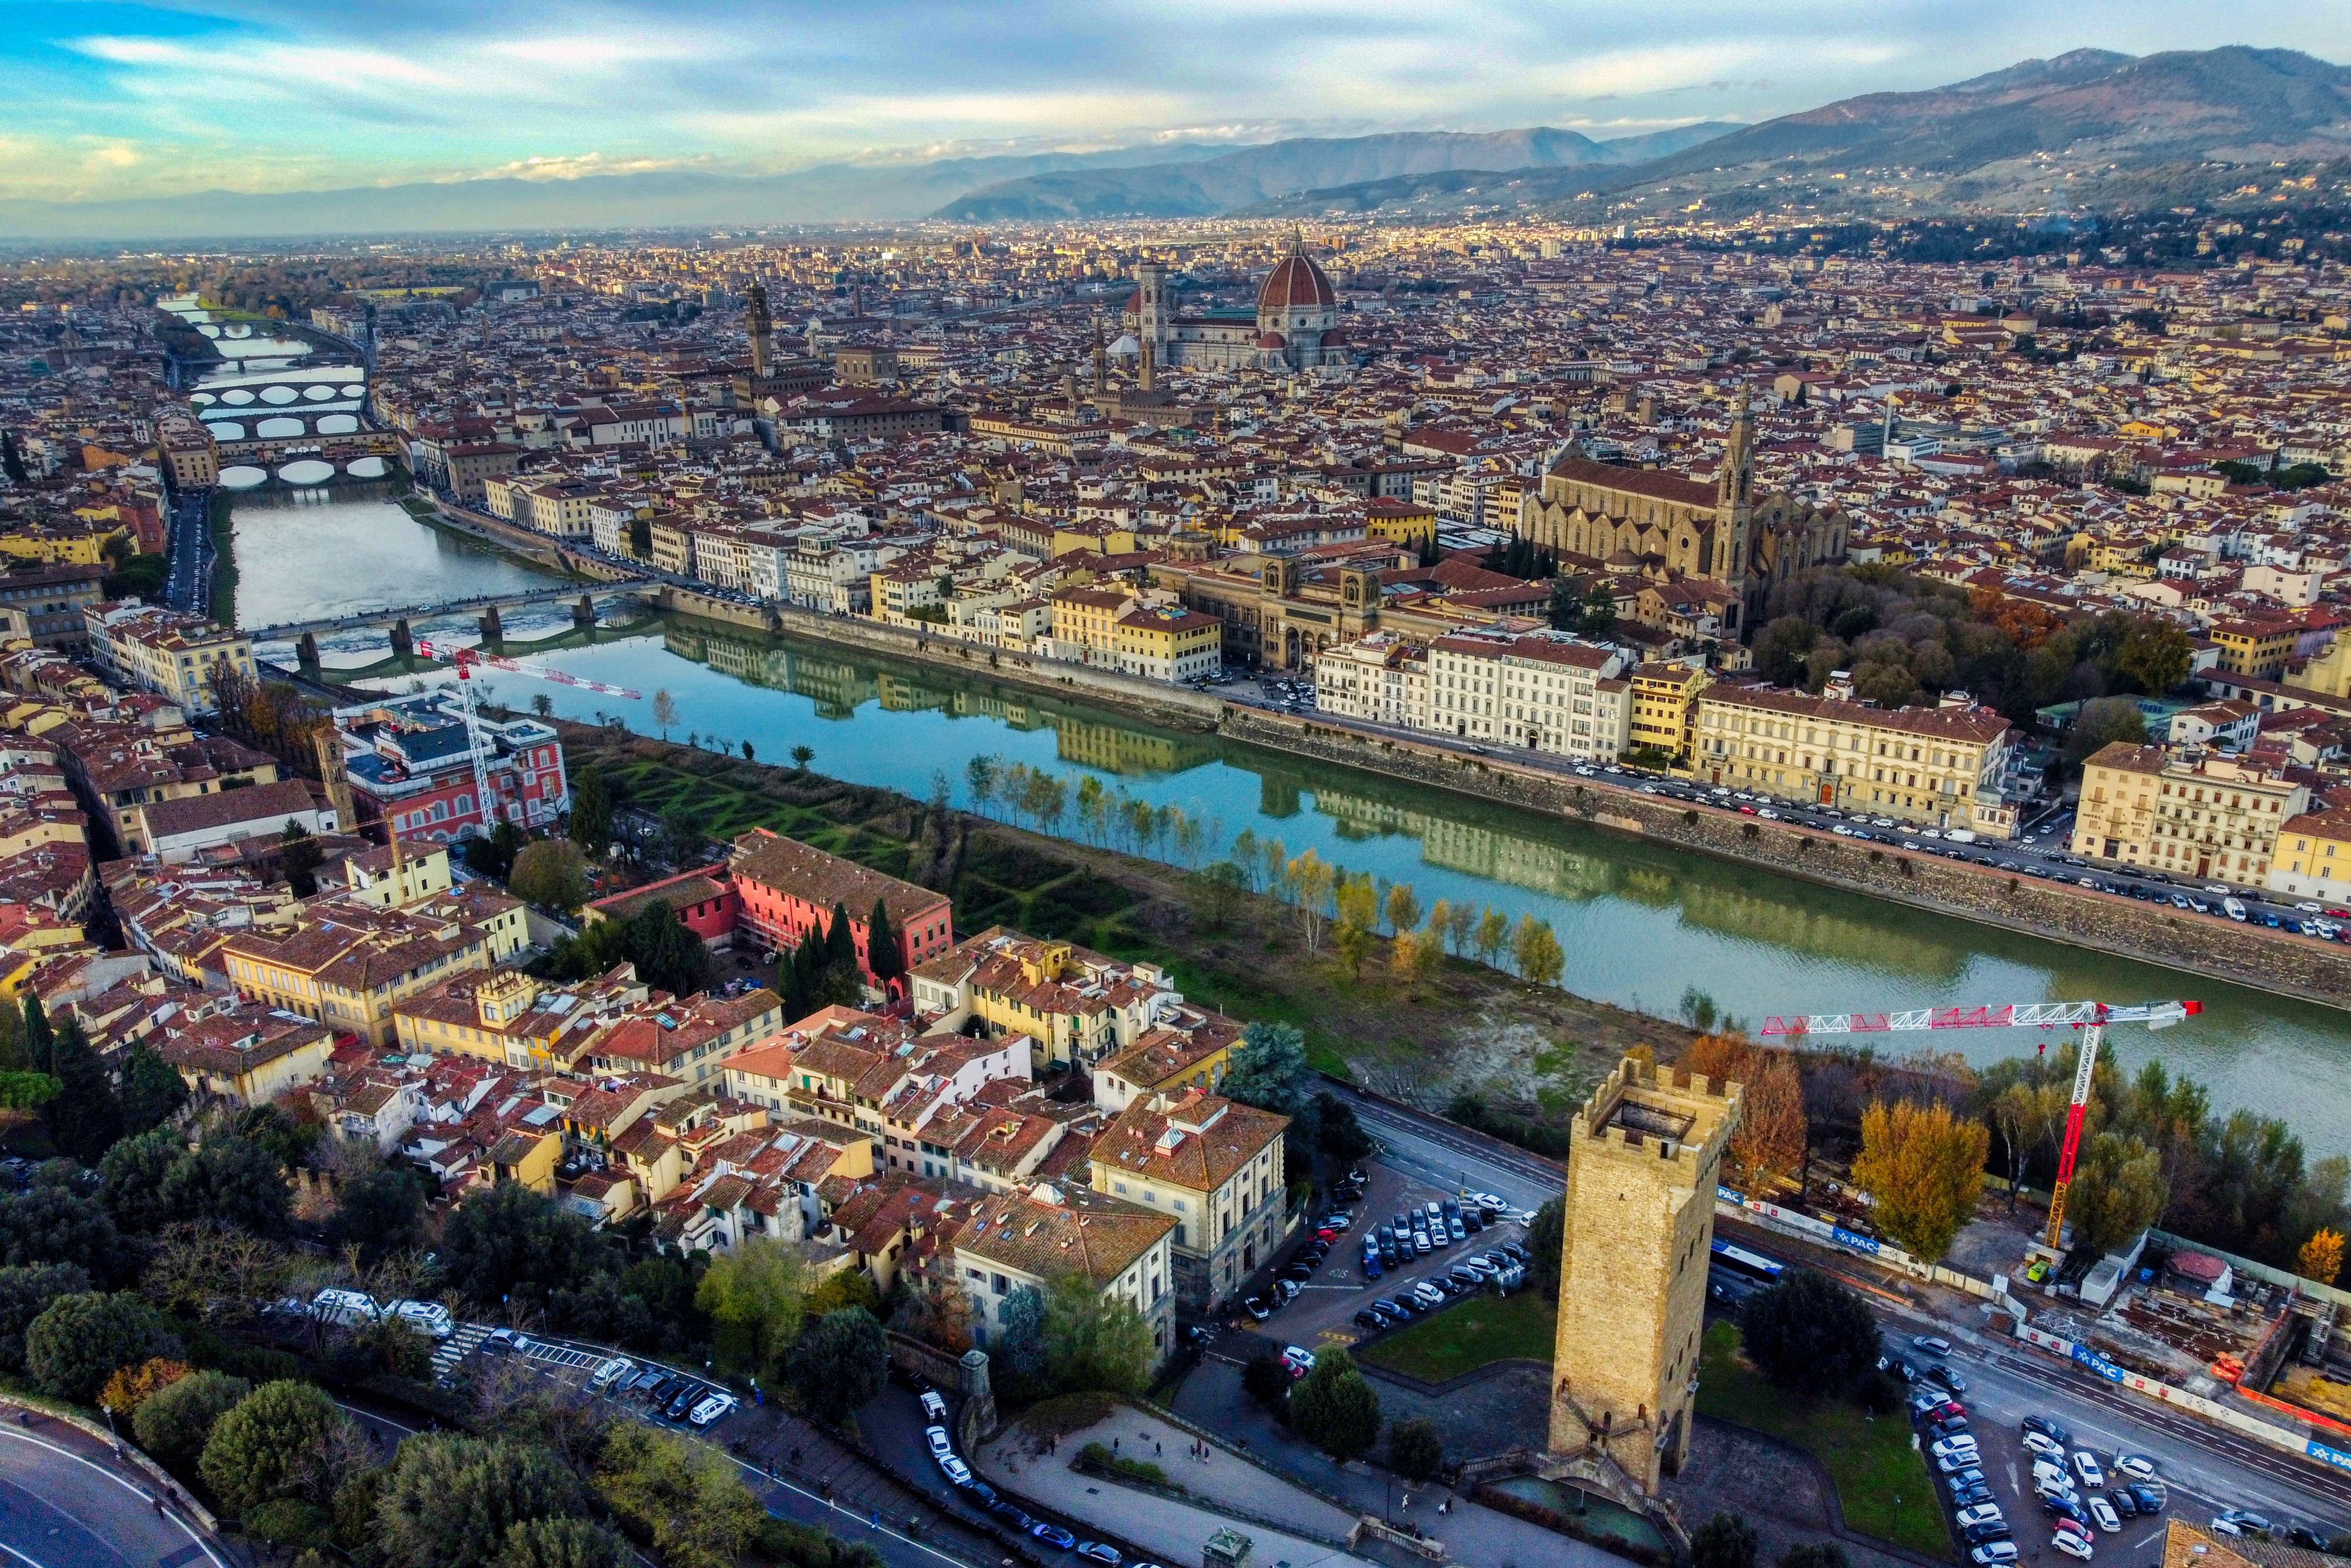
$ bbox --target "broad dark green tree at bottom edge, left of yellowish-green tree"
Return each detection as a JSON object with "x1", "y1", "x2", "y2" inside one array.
[{"x1": 376, "y1": 1432, "x2": 585, "y2": 1568}]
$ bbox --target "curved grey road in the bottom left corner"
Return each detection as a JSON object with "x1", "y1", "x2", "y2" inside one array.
[{"x1": 0, "y1": 1422, "x2": 228, "y2": 1568}]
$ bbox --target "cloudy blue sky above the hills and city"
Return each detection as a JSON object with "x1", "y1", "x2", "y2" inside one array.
[{"x1": 0, "y1": 0, "x2": 2351, "y2": 200}]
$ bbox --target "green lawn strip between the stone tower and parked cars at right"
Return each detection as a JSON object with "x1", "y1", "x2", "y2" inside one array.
[{"x1": 1697, "y1": 1324, "x2": 1951, "y2": 1556}]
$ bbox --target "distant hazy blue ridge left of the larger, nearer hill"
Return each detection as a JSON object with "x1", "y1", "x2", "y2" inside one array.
[{"x1": 933, "y1": 122, "x2": 1740, "y2": 223}]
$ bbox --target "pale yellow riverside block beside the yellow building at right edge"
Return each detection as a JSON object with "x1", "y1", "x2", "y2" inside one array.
[{"x1": 2074, "y1": 741, "x2": 2311, "y2": 886}]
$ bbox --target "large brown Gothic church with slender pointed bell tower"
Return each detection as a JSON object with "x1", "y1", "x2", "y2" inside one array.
[{"x1": 1519, "y1": 393, "x2": 1848, "y2": 639}]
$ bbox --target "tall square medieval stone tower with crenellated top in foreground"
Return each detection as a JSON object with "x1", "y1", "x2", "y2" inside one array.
[{"x1": 1552, "y1": 1058, "x2": 1740, "y2": 1497}]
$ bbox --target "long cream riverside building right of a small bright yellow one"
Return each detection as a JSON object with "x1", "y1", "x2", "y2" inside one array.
[{"x1": 1693, "y1": 677, "x2": 2017, "y2": 839}]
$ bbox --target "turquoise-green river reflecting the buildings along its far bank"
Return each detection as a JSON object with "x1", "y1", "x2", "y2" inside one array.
[{"x1": 235, "y1": 496, "x2": 2351, "y2": 1154}]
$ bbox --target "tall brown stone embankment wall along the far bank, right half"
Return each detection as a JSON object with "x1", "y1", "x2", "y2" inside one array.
[{"x1": 1218, "y1": 705, "x2": 2351, "y2": 1009}]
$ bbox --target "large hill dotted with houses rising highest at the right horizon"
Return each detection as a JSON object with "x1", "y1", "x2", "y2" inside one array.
[{"x1": 1255, "y1": 47, "x2": 2351, "y2": 219}]
